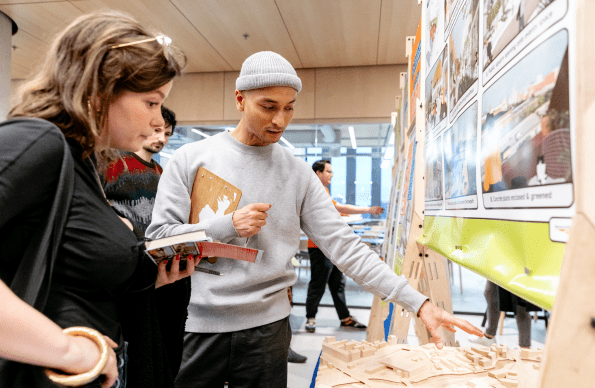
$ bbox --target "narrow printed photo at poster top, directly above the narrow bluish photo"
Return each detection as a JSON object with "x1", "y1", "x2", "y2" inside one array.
[{"x1": 448, "y1": 0, "x2": 479, "y2": 112}]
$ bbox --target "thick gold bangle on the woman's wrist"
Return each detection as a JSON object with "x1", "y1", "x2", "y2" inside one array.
[{"x1": 44, "y1": 326, "x2": 109, "y2": 387}]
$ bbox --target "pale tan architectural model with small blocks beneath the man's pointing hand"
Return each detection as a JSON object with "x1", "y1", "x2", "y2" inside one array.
[{"x1": 316, "y1": 335, "x2": 542, "y2": 388}]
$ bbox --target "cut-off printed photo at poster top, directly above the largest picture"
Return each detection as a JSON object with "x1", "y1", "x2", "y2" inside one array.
[{"x1": 482, "y1": 0, "x2": 568, "y2": 81}]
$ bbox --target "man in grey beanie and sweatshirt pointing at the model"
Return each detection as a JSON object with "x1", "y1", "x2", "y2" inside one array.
[{"x1": 147, "y1": 52, "x2": 483, "y2": 388}]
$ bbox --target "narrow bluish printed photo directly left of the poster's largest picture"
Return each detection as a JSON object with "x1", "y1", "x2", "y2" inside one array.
[{"x1": 443, "y1": 102, "x2": 478, "y2": 209}]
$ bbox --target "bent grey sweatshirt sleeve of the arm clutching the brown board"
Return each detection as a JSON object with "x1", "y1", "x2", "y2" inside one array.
[{"x1": 145, "y1": 148, "x2": 239, "y2": 242}]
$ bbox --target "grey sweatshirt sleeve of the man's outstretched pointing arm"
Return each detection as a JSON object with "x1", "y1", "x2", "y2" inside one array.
[{"x1": 300, "y1": 173, "x2": 427, "y2": 313}]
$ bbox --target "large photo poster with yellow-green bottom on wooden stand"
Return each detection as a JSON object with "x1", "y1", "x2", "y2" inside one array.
[{"x1": 418, "y1": 0, "x2": 576, "y2": 309}]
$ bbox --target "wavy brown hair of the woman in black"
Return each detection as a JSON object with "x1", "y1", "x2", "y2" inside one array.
[{"x1": 8, "y1": 11, "x2": 186, "y2": 157}]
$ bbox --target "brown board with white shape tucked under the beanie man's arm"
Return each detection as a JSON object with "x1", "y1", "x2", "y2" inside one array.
[{"x1": 188, "y1": 167, "x2": 242, "y2": 263}]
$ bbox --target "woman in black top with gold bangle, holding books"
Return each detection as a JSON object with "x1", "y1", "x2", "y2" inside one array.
[{"x1": 0, "y1": 12, "x2": 194, "y2": 388}]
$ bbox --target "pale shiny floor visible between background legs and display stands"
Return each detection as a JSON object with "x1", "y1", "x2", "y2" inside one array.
[{"x1": 287, "y1": 265, "x2": 546, "y2": 388}]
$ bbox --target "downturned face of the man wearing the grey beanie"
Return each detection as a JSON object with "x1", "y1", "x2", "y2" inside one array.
[{"x1": 236, "y1": 86, "x2": 297, "y2": 146}]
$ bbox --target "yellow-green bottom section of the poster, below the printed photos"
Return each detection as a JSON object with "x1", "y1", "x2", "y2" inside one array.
[{"x1": 418, "y1": 216, "x2": 566, "y2": 310}]
